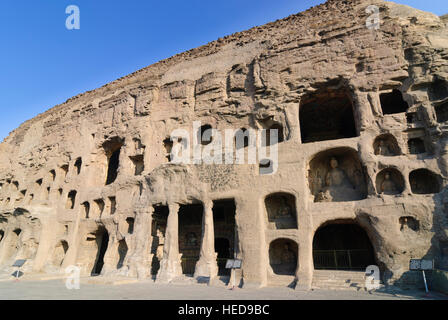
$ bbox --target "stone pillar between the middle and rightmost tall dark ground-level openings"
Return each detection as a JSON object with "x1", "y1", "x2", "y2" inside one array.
[{"x1": 194, "y1": 201, "x2": 218, "y2": 280}]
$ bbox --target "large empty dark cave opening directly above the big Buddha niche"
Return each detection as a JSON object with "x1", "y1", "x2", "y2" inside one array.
[{"x1": 299, "y1": 89, "x2": 358, "y2": 143}]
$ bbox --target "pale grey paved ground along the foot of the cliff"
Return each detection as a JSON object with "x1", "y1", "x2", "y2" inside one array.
[{"x1": 0, "y1": 279, "x2": 448, "y2": 300}]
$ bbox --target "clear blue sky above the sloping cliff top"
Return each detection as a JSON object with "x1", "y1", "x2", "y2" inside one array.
[{"x1": 0, "y1": 0, "x2": 448, "y2": 141}]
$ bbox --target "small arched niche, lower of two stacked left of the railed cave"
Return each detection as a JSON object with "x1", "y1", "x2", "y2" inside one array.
[{"x1": 269, "y1": 239, "x2": 299, "y2": 276}]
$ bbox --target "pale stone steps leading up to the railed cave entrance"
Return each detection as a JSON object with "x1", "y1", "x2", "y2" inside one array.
[{"x1": 311, "y1": 270, "x2": 378, "y2": 291}]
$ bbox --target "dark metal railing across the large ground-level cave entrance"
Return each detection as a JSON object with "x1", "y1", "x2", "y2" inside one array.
[{"x1": 313, "y1": 249, "x2": 372, "y2": 271}]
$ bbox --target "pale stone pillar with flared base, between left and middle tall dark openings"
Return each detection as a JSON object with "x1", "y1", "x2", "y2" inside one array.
[{"x1": 156, "y1": 203, "x2": 182, "y2": 283}]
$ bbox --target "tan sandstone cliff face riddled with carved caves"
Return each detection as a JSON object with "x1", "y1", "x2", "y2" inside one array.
[{"x1": 0, "y1": 0, "x2": 448, "y2": 288}]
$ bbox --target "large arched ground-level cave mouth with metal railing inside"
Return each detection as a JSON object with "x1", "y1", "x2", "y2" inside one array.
[{"x1": 313, "y1": 220, "x2": 376, "y2": 271}]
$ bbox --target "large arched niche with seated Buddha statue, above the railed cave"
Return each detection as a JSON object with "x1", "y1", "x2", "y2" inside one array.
[{"x1": 308, "y1": 148, "x2": 367, "y2": 202}]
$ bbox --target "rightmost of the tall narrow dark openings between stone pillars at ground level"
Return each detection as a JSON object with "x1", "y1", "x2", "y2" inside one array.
[{"x1": 213, "y1": 199, "x2": 237, "y2": 276}]
